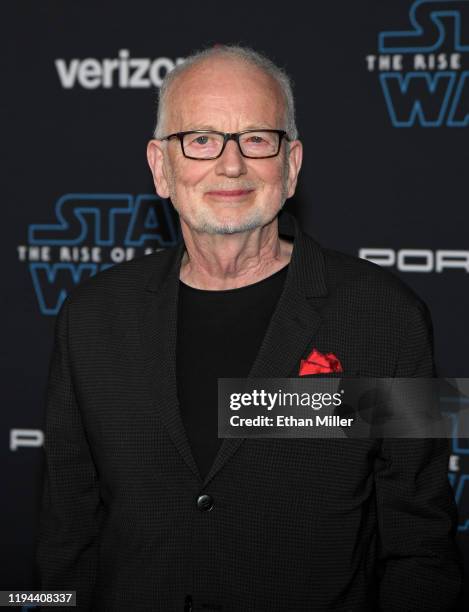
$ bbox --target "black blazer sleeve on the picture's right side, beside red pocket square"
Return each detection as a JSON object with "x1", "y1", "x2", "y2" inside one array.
[{"x1": 375, "y1": 303, "x2": 462, "y2": 612}]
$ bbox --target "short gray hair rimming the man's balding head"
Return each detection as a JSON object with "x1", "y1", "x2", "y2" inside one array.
[{"x1": 154, "y1": 45, "x2": 298, "y2": 140}]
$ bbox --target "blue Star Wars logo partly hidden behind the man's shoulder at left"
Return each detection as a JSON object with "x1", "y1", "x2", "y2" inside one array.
[{"x1": 18, "y1": 193, "x2": 180, "y2": 315}]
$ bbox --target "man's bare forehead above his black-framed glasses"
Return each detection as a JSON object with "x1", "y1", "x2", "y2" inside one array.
[{"x1": 167, "y1": 59, "x2": 284, "y2": 131}]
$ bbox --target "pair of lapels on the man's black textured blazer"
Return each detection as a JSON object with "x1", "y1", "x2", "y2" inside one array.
[{"x1": 141, "y1": 211, "x2": 336, "y2": 485}]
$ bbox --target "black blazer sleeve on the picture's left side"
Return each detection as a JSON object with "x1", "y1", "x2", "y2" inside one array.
[{"x1": 36, "y1": 297, "x2": 102, "y2": 610}]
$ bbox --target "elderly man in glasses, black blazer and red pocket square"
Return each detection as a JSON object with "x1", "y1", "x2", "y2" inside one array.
[{"x1": 37, "y1": 46, "x2": 461, "y2": 612}]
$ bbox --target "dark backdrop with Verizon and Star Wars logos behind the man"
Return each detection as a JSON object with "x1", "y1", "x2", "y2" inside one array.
[{"x1": 0, "y1": 0, "x2": 469, "y2": 610}]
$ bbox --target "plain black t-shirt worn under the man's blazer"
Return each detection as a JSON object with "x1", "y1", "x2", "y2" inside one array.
[{"x1": 176, "y1": 265, "x2": 288, "y2": 478}]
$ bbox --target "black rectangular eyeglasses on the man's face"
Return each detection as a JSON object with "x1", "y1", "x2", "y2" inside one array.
[{"x1": 161, "y1": 130, "x2": 290, "y2": 159}]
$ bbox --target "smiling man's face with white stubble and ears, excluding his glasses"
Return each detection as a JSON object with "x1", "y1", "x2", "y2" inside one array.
[{"x1": 148, "y1": 59, "x2": 302, "y2": 234}]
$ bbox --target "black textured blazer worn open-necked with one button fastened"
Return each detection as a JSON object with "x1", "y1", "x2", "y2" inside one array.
[{"x1": 37, "y1": 212, "x2": 462, "y2": 612}]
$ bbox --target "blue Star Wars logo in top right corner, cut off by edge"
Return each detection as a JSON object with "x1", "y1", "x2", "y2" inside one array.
[{"x1": 366, "y1": 0, "x2": 469, "y2": 128}]
